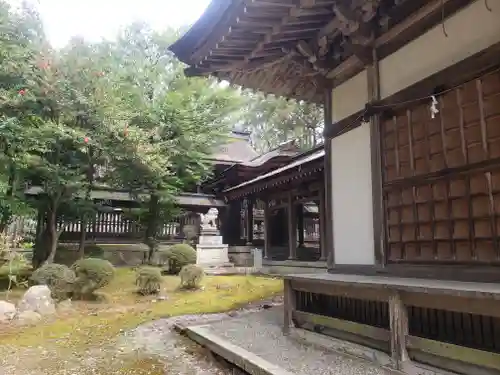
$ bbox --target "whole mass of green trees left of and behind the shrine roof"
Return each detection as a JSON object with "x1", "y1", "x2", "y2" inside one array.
[{"x1": 0, "y1": 0, "x2": 322, "y2": 269}]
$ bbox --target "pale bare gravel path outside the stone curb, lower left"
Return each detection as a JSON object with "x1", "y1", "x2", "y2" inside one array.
[{"x1": 0, "y1": 299, "x2": 281, "y2": 375}]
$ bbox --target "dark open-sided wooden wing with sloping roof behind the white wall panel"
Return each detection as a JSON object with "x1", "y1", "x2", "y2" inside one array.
[{"x1": 222, "y1": 146, "x2": 327, "y2": 273}]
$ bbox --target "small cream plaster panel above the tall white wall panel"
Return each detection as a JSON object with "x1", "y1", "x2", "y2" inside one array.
[{"x1": 332, "y1": 70, "x2": 368, "y2": 122}]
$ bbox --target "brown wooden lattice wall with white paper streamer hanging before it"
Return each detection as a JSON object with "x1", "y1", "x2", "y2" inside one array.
[{"x1": 381, "y1": 71, "x2": 500, "y2": 264}]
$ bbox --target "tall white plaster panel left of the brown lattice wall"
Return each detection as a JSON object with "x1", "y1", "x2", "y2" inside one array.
[{"x1": 331, "y1": 124, "x2": 375, "y2": 265}]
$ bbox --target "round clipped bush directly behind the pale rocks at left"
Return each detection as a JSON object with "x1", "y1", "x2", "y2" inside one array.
[{"x1": 30, "y1": 263, "x2": 76, "y2": 301}]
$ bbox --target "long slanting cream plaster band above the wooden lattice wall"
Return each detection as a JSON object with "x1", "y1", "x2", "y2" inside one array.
[{"x1": 379, "y1": 0, "x2": 500, "y2": 99}]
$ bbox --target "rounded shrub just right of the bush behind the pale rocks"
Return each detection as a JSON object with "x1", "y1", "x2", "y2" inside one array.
[{"x1": 71, "y1": 258, "x2": 115, "y2": 298}]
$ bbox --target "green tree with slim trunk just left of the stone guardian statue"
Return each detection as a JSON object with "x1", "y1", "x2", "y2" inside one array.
[{"x1": 103, "y1": 24, "x2": 241, "y2": 260}]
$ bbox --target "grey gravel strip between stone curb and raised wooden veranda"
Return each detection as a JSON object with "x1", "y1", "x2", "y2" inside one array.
[{"x1": 203, "y1": 308, "x2": 394, "y2": 375}]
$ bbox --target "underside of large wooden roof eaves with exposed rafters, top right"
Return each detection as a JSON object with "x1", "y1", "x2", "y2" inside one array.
[{"x1": 170, "y1": 0, "x2": 470, "y2": 103}]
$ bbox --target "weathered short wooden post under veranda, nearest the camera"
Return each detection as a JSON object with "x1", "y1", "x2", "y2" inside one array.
[{"x1": 389, "y1": 293, "x2": 409, "y2": 370}]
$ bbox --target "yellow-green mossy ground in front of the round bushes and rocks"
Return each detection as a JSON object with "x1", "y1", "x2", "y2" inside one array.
[{"x1": 0, "y1": 268, "x2": 282, "y2": 375}]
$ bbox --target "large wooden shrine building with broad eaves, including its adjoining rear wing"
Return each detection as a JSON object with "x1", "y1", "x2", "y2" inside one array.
[{"x1": 170, "y1": 0, "x2": 500, "y2": 375}]
